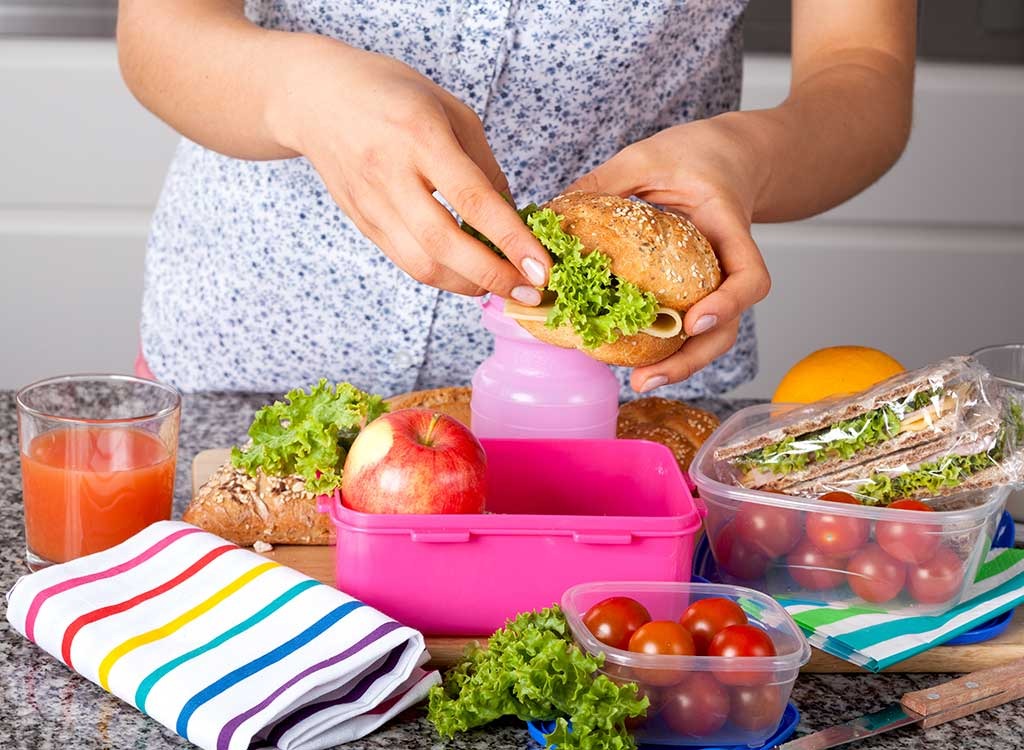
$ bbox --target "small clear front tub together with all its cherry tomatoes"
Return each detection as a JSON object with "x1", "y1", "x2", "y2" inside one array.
[{"x1": 561, "y1": 582, "x2": 811, "y2": 746}]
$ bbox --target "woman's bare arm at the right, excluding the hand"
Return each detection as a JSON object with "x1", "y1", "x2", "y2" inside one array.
[{"x1": 728, "y1": 0, "x2": 916, "y2": 221}]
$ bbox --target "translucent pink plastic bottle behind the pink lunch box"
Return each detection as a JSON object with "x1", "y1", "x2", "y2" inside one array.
[{"x1": 470, "y1": 295, "x2": 620, "y2": 440}]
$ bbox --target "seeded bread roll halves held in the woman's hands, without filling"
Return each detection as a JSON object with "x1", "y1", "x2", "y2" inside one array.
[{"x1": 518, "y1": 192, "x2": 722, "y2": 367}]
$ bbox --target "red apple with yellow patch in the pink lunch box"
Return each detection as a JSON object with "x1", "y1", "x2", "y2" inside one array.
[{"x1": 341, "y1": 409, "x2": 487, "y2": 513}]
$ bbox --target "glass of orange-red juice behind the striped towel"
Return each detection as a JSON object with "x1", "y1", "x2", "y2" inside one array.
[{"x1": 16, "y1": 375, "x2": 181, "y2": 570}]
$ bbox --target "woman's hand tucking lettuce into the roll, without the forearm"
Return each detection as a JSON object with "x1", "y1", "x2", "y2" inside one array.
[{"x1": 267, "y1": 35, "x2": 551, "y2": 304}]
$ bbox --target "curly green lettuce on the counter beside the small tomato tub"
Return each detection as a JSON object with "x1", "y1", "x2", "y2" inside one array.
[{"x1": 427, "y1": 607, "x2": 649, "y2": 750}]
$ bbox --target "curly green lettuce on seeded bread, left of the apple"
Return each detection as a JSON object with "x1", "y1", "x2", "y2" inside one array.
[{"x1": 231, "y1": 379, "x2": 387, "y2": 495}]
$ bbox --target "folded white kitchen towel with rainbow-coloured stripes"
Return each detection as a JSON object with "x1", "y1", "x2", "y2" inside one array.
[{"x1": 7, "y1": 522, "x2": 440, "y2": 750}]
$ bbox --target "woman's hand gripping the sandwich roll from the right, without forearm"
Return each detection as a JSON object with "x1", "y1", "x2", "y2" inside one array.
[{"x1": 566, "y1": 114, "x2": 771, "y2": 392}]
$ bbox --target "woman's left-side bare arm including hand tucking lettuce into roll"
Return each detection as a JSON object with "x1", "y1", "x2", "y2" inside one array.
[{"x1": 118, "y1": 0, "x2": 550, "y2": 304}]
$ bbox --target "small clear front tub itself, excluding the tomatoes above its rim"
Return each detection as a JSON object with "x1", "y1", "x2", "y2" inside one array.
[{"x1": 561, "y1": 581, "x2": 811, "y2": 747}]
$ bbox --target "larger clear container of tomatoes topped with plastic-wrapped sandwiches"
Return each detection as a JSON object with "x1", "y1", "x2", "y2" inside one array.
[{"x1": 690, "y1": 357, "x2": 1024, "y2": 614}]
